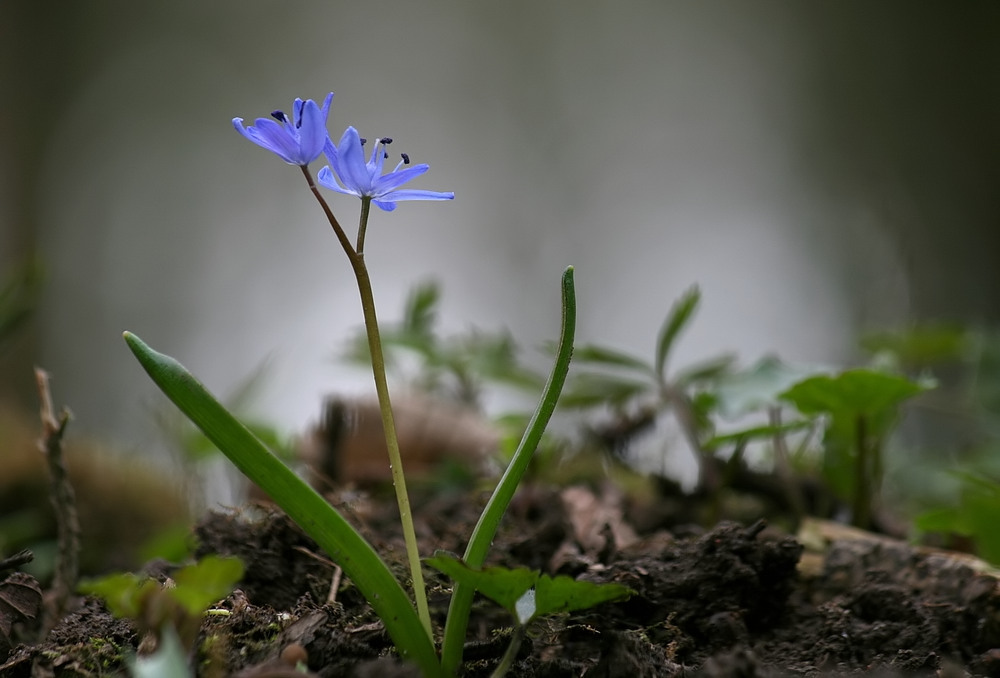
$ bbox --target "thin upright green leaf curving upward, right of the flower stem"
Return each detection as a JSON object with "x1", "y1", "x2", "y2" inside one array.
[{"x1": 441, "y1": 266, "x2": 576, "y2": 676}]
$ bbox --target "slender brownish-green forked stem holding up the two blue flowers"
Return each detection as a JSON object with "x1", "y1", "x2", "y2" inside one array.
[{"x1": 302, "y1": 166, "x2": 434, "y2": 639}]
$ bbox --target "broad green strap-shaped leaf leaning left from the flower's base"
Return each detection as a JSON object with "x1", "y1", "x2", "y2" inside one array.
[{"x1": 124, "y1": 332, "x2": 441, "y2": 676}]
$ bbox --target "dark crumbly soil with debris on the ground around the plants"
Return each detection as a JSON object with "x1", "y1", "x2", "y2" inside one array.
[{"x1": 0, "y1": 480, "x2": 1000, "y2": 678}]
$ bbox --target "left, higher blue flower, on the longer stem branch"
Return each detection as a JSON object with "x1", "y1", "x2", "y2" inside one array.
[{"x1": 233, "y1": 92, "x2": 333, "y2": 165}]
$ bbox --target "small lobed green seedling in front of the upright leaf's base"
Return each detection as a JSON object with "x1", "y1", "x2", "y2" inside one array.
[{"x1": 424, "y1": 552, "x2": 635, "y2": 678}]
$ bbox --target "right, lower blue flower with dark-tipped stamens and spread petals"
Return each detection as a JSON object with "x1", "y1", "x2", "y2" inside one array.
[{"x1": 317, "y1": 127, "x2": 455, "y2": 212}]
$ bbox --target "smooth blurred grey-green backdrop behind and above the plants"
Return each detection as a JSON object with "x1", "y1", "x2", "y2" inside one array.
[{"x1": 0, "y1": 0, "x2": 1000, "y2": 462}]
